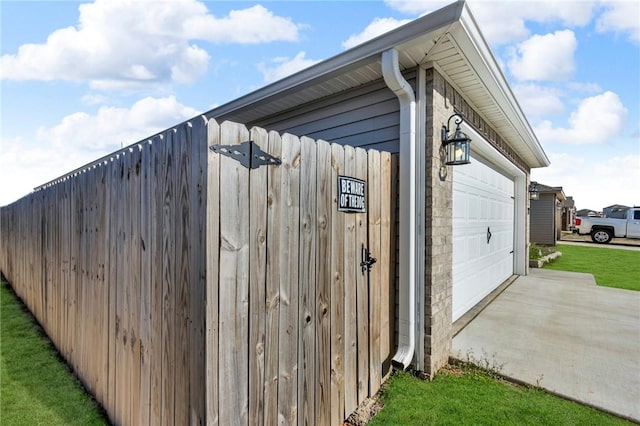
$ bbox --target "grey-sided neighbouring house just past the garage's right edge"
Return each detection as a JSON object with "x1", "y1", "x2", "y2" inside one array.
[{"x1": 529, "y1": 183, "x2": 567, "y2": 245}]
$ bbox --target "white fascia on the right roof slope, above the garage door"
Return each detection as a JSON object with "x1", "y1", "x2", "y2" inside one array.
[{"x1": 451, "y1": 4, "x2": 550, "y2": 168}]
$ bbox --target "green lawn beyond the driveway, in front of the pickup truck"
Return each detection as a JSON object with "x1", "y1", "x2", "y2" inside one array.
[{"x1": 544, "y1": 244, "x2": 640, "y2": 291}]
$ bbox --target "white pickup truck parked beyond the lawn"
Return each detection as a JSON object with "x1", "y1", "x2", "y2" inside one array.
[{"x1": 576, "y1": 207, "x2": 640, "y2": 244}]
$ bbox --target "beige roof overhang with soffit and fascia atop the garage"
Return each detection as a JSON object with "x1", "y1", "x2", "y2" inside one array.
[{"x1": 207, "y1": 2, "x2": 549, "y2": 168}]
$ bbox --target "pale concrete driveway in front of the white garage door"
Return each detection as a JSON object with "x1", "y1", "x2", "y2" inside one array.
[{"x1": 451, "y1": 269, "x2": 640, "y2": 422}]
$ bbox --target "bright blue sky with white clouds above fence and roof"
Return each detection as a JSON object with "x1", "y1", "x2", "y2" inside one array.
[{"x1": 0, "y1": 0, "x2": 640, "y2": 210}]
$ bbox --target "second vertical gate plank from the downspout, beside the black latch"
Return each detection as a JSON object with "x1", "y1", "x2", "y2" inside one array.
[{"x1": 367, "y1": 150, "x2": 385, "y2": 395}]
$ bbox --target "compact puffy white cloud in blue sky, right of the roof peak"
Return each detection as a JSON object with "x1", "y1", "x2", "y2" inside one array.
[{"x1": 508, "y1": 30, "x2": 578, "y2": 81}]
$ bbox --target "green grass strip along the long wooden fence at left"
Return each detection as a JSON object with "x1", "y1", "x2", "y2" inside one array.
[{"x1": 0, "y1": 281, "x2": 108, "y2": 426}]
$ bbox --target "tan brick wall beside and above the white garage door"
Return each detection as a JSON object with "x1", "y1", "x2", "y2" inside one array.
[{"x1": 424, "y1": 68, "x2": 529, "y2": 377}]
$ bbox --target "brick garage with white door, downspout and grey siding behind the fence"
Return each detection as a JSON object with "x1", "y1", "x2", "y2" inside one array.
[{"x1": 206, "y1": 1, "x2": 553, "y2": 376}]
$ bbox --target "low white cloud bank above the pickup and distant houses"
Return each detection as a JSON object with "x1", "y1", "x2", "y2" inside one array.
[{"x1": 531, "y1": 152, "x2": 640, "y2": 211}]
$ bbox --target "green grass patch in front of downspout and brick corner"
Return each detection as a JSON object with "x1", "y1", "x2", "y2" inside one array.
[{"x1": 369, "y1": 366, "x2": 631, "y2": 426}]
